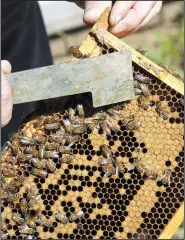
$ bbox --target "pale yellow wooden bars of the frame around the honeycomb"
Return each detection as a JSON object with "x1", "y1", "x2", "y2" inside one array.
[{"x1": 71, "y1": 8, "x2": 184, "y2": 239}]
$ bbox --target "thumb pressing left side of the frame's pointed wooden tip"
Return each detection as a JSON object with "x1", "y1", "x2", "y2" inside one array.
[{"x1": 83, "y1": 1, "x2": 112, "y2": 24}]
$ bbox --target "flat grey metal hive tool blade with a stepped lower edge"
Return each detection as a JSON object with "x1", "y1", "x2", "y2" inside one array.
[{"x1": 7, "y1": 50, "x2": 135, "y2": 107}]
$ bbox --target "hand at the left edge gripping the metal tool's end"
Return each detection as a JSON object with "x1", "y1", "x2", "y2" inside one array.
[{"x1": 1, "y1": 60, "x2": 13, "y2": 127}]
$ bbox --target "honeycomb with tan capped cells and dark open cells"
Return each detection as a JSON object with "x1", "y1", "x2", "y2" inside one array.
[{"x1": 1, "y1": 8, "x2": 184, "y2": 239}]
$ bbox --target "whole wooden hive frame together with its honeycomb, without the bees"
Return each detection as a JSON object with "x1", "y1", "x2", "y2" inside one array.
[{"x1": 1, "y1": 9, "x2": 184, "y2": 239}]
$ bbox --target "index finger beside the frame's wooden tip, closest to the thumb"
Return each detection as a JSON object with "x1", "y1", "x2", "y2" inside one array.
[{"x1": 109, "y1": 1, "x2": 137, "y2": 27}]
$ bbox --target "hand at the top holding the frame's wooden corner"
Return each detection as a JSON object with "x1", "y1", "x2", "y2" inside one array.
[{"x1": 77, "y1": 1, "x2": 162, "y2": 38}]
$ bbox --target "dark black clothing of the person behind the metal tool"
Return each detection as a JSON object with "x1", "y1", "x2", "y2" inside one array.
[{"x1": 1, "y1": 0, "x2": 52, "y2": 146}]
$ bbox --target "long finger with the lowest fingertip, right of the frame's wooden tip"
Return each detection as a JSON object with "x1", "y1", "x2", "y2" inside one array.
[{"x1": 109, "y1": 1, "x2": 156, "y2": 37}]
